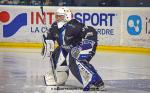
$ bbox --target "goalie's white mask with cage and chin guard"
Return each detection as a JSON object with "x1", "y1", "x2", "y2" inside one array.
[{"x1": 56, "y1": 7, "x2": 72, "y2": 28}]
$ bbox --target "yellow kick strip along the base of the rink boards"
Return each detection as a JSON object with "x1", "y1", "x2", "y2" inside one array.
[{"x1": 0, "y1": 42, "x2": 150, "y2": 55}]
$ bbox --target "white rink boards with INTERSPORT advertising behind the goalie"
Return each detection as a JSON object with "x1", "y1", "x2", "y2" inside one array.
[{"x1": 0, "y1": 5, "x2": 150, "y2": 48}]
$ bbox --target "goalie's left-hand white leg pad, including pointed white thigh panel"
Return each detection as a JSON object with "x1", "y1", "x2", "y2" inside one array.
[{"x1": 45, "y1": 51, "x2": 69, "y2": 86}]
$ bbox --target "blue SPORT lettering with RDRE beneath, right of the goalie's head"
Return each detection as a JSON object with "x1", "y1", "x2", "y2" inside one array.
[{"x1": 74, "y1": 12, "x2": 117, "y2": 35}]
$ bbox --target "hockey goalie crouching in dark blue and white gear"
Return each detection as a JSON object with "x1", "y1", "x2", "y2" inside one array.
[{"x1": 42, "y1": 7, "x2": 104, "y2": 90}]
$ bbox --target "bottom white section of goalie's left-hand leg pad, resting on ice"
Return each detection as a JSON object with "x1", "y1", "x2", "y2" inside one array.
[{"x1": 44, "y1": 71, "x2": 68, "y2": 86}]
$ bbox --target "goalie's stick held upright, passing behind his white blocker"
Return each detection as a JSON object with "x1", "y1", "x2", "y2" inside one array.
[{"x1": 40, "y1": 0, "x2": 58, "y2": 90}]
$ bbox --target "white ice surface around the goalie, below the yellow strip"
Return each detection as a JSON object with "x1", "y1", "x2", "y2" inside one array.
[{"x1": 0, "y1": 48, "x2": 150, "y2": 93}]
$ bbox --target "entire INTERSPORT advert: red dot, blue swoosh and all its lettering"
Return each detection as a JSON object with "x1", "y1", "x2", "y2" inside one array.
[{"x1": 0, "y1": 11, "x2": 116, "y2": 38}]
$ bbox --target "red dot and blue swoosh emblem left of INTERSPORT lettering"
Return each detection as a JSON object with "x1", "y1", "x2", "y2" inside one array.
[{"x1": 0, "y1": 11, "x2": 27, "y2": 37}]
